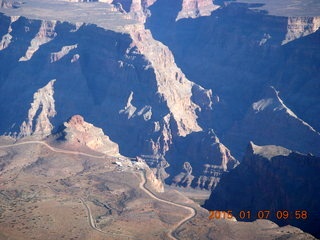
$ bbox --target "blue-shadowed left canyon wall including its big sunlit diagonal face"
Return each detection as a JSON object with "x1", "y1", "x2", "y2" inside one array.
[{"x1": 0, "y1": 1, "x2": 235, "y2": 188}]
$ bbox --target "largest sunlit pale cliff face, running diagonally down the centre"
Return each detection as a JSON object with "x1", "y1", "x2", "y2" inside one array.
[{"x1": 131, "y1": 26, "x2": 202, "y2": 136}]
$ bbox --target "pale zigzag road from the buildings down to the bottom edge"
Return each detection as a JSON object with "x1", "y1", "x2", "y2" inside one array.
[{"x1": 139, "y1": 171, "x2": 197, "y2": 240}]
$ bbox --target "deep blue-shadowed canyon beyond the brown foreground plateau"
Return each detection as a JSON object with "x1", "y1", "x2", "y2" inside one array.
[{"x1": 0, "y1": 0, "x2": 320, "y2": 239}]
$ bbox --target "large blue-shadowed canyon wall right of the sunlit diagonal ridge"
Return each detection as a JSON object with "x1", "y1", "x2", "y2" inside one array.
[{"x1": 146, "y1": 0, "x2": 320, "y2": 159}]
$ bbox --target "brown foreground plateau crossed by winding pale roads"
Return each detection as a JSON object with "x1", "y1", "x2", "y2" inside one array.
[{"x1": 0, "y1": 134, "x2": 314, "y2": 240}]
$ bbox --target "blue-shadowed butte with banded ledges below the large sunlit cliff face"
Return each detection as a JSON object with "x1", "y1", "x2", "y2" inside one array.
[{"x1": 168, "y1": 130, "x2": 239, "y2": 189}]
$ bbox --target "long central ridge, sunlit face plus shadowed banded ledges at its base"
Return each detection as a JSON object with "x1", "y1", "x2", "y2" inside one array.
[{"x1": 119, "y1": 1, "x2": 231, "y2": 189}]
